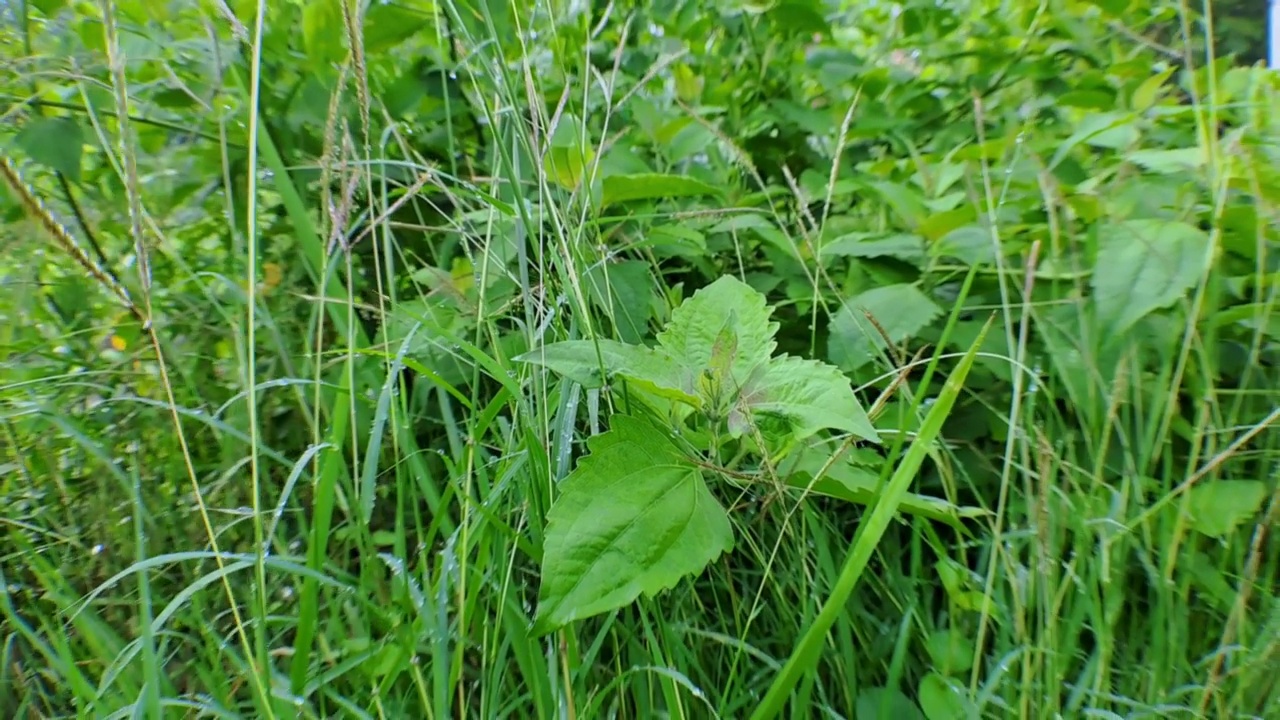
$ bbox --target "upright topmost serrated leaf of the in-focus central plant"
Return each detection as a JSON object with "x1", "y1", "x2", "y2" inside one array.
[{"x1": 658, "y1": 275, "x2": 778, "y2": 387}]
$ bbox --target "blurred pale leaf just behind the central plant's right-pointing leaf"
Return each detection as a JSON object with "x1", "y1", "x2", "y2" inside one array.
[{"x1": 828, "y1": 283, "x2": 942, "y2": 370}]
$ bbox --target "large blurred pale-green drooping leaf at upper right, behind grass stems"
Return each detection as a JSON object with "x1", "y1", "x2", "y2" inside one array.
[{"x1": 1093, "y1": 219, "x2": 1210, "y2": 334}]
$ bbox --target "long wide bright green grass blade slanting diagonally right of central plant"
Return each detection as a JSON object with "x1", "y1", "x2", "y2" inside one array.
[{"x1": 751, "y1": 320, "x2": 991, "y2": 720}]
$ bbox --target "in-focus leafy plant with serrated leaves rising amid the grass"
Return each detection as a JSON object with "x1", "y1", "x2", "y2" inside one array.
[{"x1": 517, "y1": 275, "x2": 972, "y2": 633}]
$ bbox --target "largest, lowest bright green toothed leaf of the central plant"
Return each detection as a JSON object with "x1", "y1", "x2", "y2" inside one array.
[{"x1": 534, "y1": 415, "x2": 733, "y2": 635}]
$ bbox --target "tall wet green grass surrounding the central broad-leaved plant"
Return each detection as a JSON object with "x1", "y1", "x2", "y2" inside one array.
[{"x1": 0, "y1": 4, "x2": 1280, "y2": 719}]
